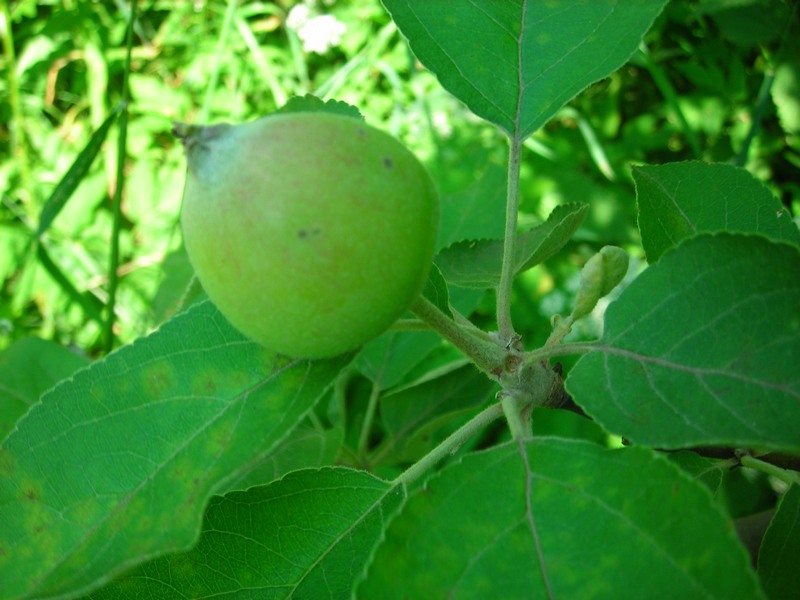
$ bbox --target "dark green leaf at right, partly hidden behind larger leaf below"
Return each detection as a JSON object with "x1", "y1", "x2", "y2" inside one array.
[{"x1": 633, "y1": 162, "x2": 800, "y2": 263}]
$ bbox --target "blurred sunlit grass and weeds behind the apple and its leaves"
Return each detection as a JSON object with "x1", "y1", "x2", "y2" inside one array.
[{"x1": 0, "y1": 0, "x2": 800, "y2": 357}]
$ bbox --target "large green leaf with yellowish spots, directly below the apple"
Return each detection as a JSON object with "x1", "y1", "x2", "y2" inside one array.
[{"x1": 0, "y1": 301, "x2": 347, "y2": 598}]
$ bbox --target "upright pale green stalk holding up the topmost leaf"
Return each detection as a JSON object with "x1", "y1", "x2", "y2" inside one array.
[{"x1": 497, "y1": 131, "x2": 522, "y2": 341}]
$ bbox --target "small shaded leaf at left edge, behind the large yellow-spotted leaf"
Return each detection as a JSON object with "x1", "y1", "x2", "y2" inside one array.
[{"x1": 0, "y1": 337, "x2": 89, "y2": 440}]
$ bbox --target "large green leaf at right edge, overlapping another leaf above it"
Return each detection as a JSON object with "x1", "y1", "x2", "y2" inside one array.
[{"x1": 567, "y1": 234, "x2": 800, "y2": 452}]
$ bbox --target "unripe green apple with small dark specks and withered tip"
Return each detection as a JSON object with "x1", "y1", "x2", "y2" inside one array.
[{"x1": 176, "y1": 112, "x2": 439, "y2": 359}]
